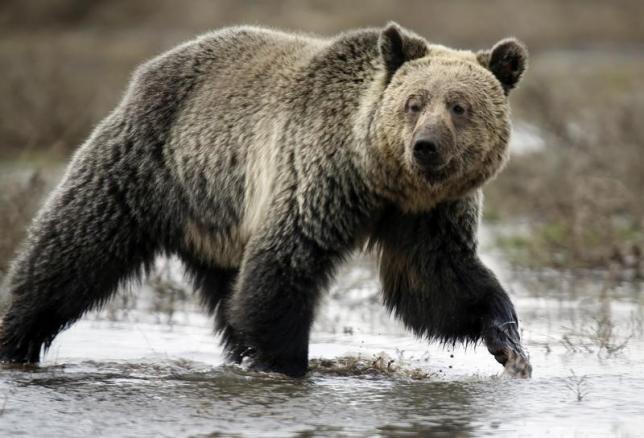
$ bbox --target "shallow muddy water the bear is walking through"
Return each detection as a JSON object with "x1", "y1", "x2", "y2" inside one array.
[{"x1": 0, "y1": 248, "x2": 644, "y2": 437}]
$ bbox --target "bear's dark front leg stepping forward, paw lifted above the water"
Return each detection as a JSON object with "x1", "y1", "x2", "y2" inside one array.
[{"x1": 372, "y1": 190, "x2": 532, "y2": 377}]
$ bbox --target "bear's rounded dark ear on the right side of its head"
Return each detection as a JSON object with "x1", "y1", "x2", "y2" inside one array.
[{"x1": 476, "y1": 38, "x2": 528, "y2": 96}]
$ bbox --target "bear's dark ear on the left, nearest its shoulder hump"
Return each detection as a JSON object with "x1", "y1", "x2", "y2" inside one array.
[{"x1": 378, "y1": 21, "x2": 428, "y2": 82}]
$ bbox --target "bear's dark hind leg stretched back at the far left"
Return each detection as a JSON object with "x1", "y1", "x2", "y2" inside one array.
[{"x1": 0, "y1": 171, "x2": 155, "y2": 363}]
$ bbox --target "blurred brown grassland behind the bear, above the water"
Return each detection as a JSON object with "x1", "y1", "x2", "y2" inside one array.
[{"x1": 0, "y1": 0, "x2": 644, "y2": 278}]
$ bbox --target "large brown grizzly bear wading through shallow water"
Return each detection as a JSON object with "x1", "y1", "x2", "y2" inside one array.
[{"x1": 0, "y1": 23, "x2": 531, "y2": 376}]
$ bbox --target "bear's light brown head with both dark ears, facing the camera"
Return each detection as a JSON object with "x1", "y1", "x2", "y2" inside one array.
[{"x1": 372, "y1": 23, "x2": 528, "y2": 211}]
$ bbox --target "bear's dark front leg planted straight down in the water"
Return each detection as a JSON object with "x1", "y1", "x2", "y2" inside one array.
[{"x1": 227, "y1": 213, "x2": 338, "y2": 377}]
